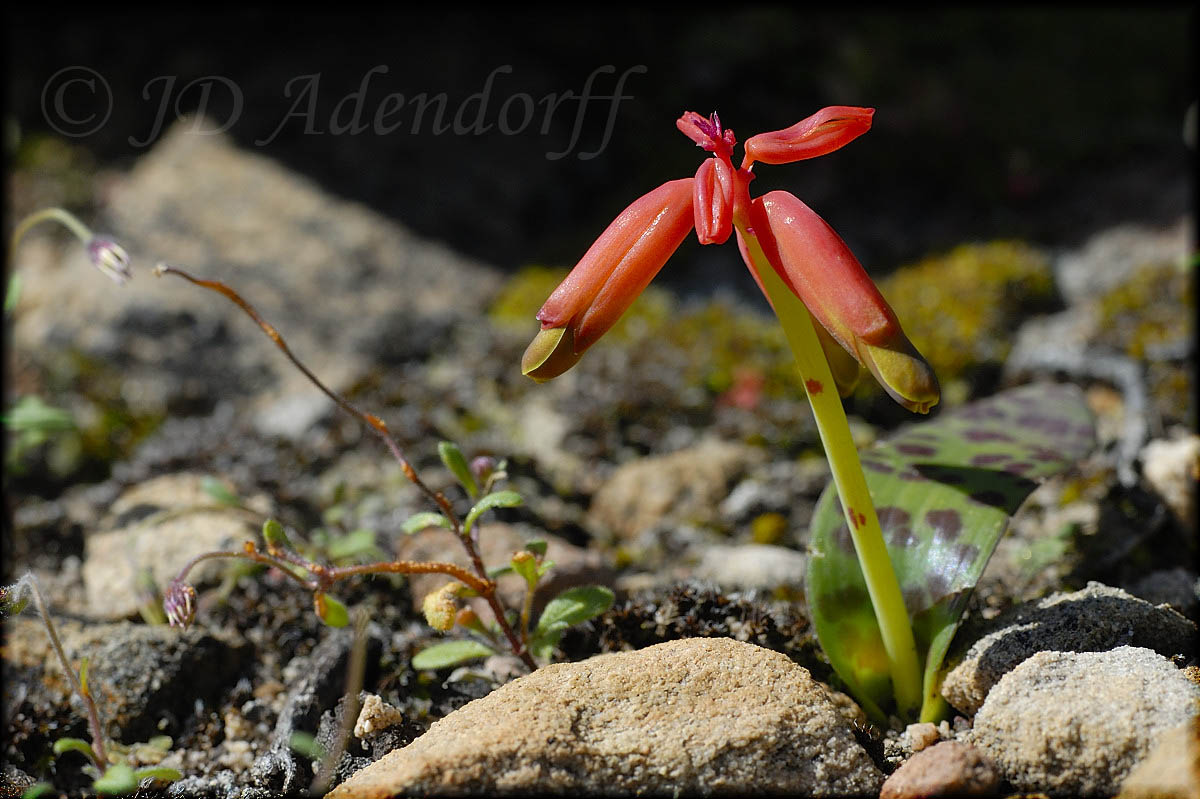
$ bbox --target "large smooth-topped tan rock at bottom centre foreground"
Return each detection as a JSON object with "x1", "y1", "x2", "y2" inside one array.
[{"x1": 329, "y1": 638, "x2": 883, "y2": 799}]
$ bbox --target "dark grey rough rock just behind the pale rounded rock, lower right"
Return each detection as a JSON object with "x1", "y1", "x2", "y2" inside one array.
[{"x1": 942, "y1": 582, "x2": 1196, "y2": 715}]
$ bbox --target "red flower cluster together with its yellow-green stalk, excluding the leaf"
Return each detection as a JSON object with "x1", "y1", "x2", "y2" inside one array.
[{"x1": 521, "y1": 106, "x2": 941, "y2": 717}]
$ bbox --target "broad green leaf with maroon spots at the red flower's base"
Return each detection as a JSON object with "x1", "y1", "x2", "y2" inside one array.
[{"x1": 808, "y1": 384, "x2": 1096, "y2": 719}]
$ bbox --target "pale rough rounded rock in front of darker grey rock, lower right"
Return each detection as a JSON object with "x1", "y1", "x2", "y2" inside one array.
[{"x1": 972, "y1": 647, "x2": 1200, "y2": 797}]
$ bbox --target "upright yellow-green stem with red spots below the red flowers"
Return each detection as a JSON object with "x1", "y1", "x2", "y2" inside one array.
[{"x1": 739, "y1": 227, "x2": 922, "y2": 717}]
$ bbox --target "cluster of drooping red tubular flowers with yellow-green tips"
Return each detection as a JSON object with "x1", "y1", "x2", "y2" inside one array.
[{"x1": 521, "y1": 106, "x2": 940, "y2": 413}]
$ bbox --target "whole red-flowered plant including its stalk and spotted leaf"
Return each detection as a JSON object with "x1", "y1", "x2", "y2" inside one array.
[{"x1": 521, "y1": 106, "x2": 1094, "y2": 720}]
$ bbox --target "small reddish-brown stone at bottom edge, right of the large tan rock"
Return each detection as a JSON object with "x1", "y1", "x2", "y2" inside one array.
[{"x1": 880, "y1": 739, "x2": 1001, "y2": 799}]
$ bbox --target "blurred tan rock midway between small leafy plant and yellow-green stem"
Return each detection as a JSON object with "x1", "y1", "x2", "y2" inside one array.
[{"x1": 589, "y1": 440, "x2": 764, "y2": 540}]
